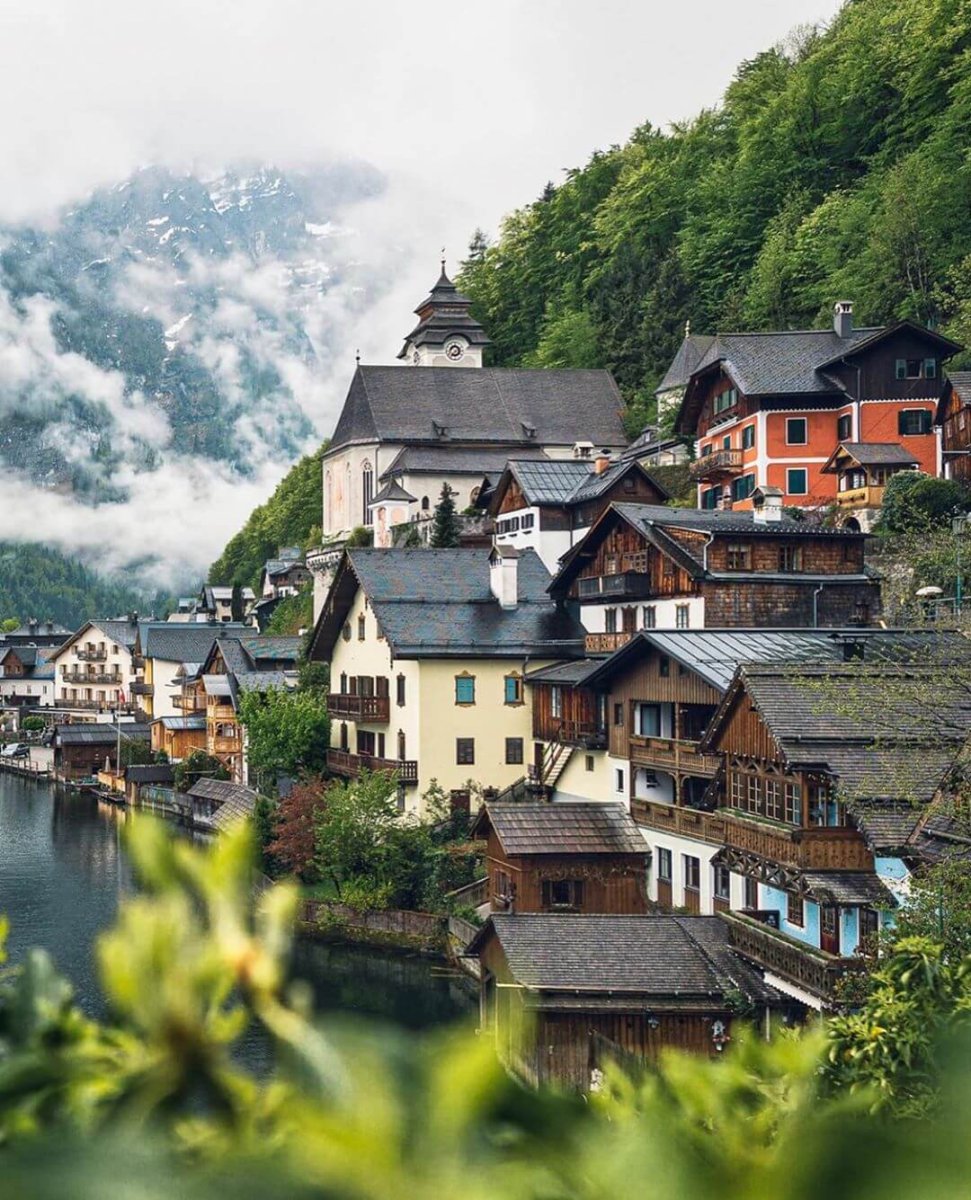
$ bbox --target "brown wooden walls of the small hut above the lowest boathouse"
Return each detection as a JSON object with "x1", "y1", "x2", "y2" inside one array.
[{"x1": 486, "y1": 829, "x2": 647, "y2": 916}]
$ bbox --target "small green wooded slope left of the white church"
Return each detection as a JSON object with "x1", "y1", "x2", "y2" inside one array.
[{"x1": 209, "y1": 443, "x2": 326, "y2": 588}]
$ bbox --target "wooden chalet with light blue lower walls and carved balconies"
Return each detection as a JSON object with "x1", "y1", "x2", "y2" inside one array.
[{"x1": 684, "y1": 641, "x2": 971, "y2": 1004}]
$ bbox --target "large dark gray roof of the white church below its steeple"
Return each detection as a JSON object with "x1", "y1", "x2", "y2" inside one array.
[{"x1": 325, "y1": 366, "x2": 628, "y2": 451}]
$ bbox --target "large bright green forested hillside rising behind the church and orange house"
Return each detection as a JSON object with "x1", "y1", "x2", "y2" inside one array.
[{"x1": 461, "y1": 0, "x2": 971, "y2": 431}]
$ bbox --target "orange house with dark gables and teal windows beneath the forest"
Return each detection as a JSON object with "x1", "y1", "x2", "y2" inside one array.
[{"x1": 675, "y1": 300, "x2": 960, "y2": 510}]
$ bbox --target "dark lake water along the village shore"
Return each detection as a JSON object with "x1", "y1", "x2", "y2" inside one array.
[{"x1": 0, "y1": 774, "x2": 473, "y2": 1066}]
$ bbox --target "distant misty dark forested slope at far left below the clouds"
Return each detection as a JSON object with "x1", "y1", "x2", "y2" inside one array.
[{"x1": 0, "y1": 541, "x2": 166, "y2": 629}]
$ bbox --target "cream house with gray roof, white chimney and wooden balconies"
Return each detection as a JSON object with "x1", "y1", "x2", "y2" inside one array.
[{"x1": 311, "y1": 547, "x2": 583, "y2": 814}]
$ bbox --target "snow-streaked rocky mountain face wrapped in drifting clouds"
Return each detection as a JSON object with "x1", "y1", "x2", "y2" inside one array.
[{"x1": 0, "y1": 166, "x2": 382, "y2": 503}]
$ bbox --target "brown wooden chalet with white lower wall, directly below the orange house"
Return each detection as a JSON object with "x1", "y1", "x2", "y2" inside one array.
[{"x1": 550, "y1": 496, "x2": 880, "y2": 654}]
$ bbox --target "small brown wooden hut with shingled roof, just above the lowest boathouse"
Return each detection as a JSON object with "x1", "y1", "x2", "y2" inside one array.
[{"x1": 472, "y1": 802, "x2": 649, "y2": 913}]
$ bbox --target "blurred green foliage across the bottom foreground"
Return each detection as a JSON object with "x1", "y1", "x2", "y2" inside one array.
[{"x1": 0, "y1": 818, "x2": 971, "y2": 1200}]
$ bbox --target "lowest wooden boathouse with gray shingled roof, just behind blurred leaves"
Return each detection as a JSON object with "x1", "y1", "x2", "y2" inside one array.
[{"x1": 467, "y1": 913, "x2": 791, "y2": 1092}]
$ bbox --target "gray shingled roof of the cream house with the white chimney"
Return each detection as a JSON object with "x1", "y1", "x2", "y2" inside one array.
[{"x1": 311, "y1": 549, "x2": 585, "y2": 661}]
